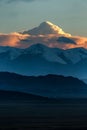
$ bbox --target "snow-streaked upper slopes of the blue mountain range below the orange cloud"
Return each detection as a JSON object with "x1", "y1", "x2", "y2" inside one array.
[{"x1": 0, "y1": 43, "x2": 87, "y2": 64}]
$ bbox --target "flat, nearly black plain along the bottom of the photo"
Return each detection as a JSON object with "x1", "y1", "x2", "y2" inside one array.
[{"x1": 0, "y1": 99, "x2": 87, "y2": 130}]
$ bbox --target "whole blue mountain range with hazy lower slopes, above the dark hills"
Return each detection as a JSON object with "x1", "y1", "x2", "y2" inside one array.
[{"x1": 0, "y1": 43, "x2": 87, "y2": 79}]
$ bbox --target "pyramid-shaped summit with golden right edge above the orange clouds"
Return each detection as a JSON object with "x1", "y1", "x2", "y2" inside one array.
[{"x1": 23, "y1": 21, "x2": 71, "y2": 36}]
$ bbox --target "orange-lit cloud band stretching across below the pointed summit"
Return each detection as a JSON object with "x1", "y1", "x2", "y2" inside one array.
[{"x1": 0, "y1": 32, "x2": 87, "y2": 49}]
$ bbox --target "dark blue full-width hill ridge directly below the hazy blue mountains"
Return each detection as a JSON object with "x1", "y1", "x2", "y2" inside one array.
[{"x1": 0, "y1": 72, "x2": 87, "y2": 98}]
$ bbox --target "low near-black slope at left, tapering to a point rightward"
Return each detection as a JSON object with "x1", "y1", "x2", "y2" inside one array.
[{"x1": 0, "y1": 90, "x2": 50, "y2": 103}]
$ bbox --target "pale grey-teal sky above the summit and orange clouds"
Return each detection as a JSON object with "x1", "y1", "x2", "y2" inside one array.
[{"x1": 0, "y1": 0, "x2": 87, "y2": 36}]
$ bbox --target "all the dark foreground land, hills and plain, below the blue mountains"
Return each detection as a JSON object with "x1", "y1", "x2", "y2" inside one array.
[{"x1": 0, "y1": 72, "x2": 87, "y2": 130}]
